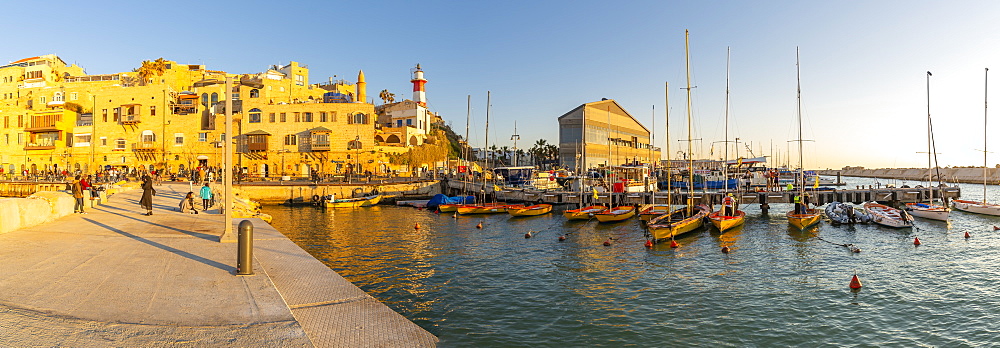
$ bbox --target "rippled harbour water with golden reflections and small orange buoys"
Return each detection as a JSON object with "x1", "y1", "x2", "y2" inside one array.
[{"x1": 264, "y1": 178, "x2": 1000, "y2": 347}]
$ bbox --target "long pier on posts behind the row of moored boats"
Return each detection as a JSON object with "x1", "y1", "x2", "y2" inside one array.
[{"x1": 442, "y1": 180, "x2": 962, "y2": 209}]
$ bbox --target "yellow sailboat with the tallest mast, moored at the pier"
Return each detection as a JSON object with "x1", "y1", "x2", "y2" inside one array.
[{"x1": 646, "y1": 30, "x2": 709, "y2": 243}]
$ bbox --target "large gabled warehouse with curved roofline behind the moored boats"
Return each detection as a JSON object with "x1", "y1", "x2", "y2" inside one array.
[{"x1": 559, "y1": 99, "x2": 660, "y2": 170}]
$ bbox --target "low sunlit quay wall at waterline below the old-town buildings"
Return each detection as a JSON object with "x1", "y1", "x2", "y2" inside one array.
[{"x1": 236, "y1": 180, "x2": 441, "y2": 204}]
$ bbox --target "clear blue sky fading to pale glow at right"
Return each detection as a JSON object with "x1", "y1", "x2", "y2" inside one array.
[{"x1": 0, "y1": 1, "x2": 1000, "y2": 169}]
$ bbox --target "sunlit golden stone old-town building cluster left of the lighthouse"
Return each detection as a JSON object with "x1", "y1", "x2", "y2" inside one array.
[{"x1": 0, "y1": 55, "x2": 434, "y2": 177}]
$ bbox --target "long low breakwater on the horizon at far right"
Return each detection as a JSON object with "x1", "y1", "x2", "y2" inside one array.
[{"x1": 817, "y1": 167, "x2": 1000, "y2": 184}]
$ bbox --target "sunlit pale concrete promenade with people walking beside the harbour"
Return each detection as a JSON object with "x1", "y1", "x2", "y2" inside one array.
[{"x1": 0, "y1": 184, "x2": 438, "y2": 347}]
